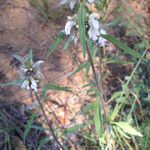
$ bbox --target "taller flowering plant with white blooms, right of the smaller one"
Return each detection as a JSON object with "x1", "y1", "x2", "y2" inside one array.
[{"x1": 47, "y1": 0, "x2": 144, "y2": 150}]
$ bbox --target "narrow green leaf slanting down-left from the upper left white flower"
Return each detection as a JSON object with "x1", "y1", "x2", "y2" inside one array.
[{"x1": 48, "y1": 32, "x2": 64, "y2": 56}]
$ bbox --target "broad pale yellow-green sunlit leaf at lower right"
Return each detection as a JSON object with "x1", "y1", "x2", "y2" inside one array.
[{"x1": 113, "y1": 121, "x2": 143, "y2": 137}]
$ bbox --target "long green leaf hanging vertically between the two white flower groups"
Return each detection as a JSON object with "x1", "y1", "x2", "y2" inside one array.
[{"x1": 78, "y1": 2, "x2": 86, "y2": 57}]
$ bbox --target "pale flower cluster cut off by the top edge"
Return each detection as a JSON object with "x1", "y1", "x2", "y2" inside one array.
[{"x1": 59, "y1": 0, "x2": 94, "y2": 10}]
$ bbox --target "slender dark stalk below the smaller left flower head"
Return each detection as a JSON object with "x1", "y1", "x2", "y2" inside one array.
[{"x1": 34, "y1": 92, "x2": 64, "y2": 150}]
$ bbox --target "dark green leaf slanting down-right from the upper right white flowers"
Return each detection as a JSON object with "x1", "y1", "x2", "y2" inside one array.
[{"x1": 102, "y1": 35, "x2": 141, "y2": 59}]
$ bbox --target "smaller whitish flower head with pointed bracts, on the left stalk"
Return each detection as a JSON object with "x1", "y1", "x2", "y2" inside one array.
[{"x1": 14, "y1": 51, "x2": 43, "y2": 92}]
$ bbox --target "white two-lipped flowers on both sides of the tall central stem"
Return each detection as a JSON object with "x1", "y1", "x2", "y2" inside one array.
[{"x1": 64, "y1": 13, "x2": 107, "y2": 47}]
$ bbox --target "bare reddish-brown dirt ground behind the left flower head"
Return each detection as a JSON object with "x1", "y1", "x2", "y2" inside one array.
[{"x1": 0, "y1": 0, "x2": 88, "y2": 129}]
